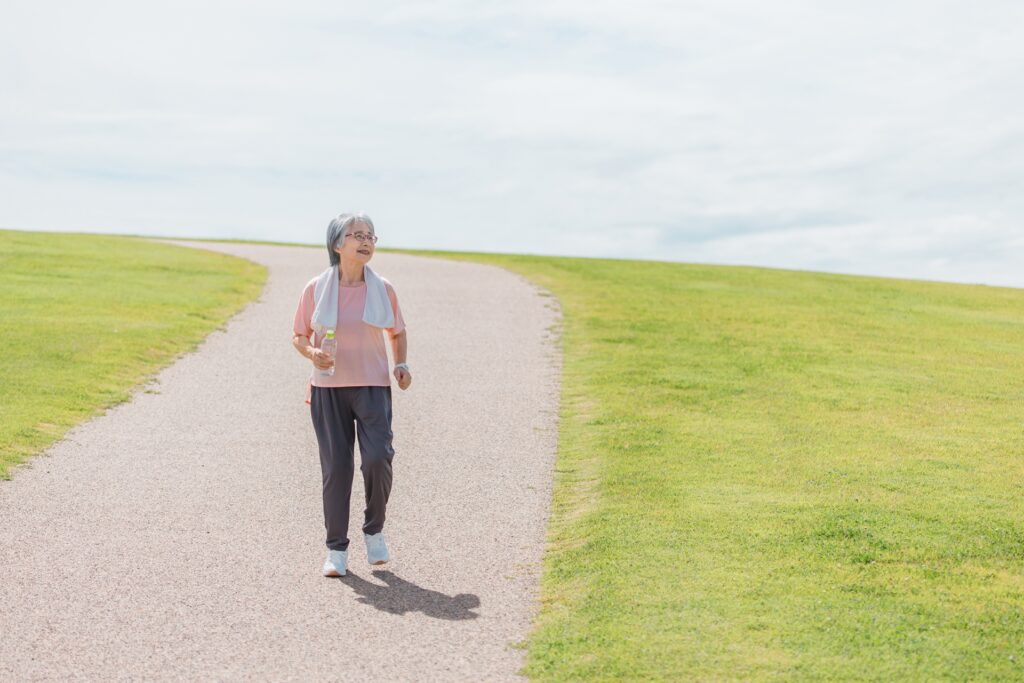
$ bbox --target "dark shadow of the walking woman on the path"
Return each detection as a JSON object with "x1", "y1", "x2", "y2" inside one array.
[{"x1": 339, "y1": 569, "x2": 480, "y2": 621}]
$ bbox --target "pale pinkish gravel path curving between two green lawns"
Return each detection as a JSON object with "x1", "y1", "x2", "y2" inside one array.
[{"x1": 0, "y1": 244, "x2": 560, "y2": 681}]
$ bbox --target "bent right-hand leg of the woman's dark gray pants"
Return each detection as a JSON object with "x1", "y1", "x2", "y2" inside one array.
[{"x1": 352, "y1": 386, "x2": 394, "y2": 535}]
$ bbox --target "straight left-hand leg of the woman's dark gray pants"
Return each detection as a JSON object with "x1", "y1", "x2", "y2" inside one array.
[{"x1": 309, "y1": 386, "x2": 355, "y2": 550}]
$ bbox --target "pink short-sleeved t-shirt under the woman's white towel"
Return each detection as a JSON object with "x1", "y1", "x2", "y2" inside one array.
[{"x1": 293, "y1": 278, "x2": 406, "y2": 403}]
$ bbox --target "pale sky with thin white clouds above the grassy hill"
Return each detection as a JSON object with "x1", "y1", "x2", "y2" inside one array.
[{"x1": 0, "y1": 0, "x2": 1024, "y2": 287}]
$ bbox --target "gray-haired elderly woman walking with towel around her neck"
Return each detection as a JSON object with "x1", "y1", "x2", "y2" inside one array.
[{"x1": 292, "y1": 213, "x2": 413, "y2": 577}]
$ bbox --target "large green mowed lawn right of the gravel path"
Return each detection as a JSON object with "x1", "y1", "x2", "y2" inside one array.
[{"x1": 395, "y1": 252, "x2": 1024, "y2": 681}]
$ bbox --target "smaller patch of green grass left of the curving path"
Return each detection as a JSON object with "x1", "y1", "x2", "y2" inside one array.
[{"x1": 0, "y1": 230, "x2": 266, "y2": 478}]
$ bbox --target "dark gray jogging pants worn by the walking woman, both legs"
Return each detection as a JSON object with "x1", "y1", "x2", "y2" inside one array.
[{"x1": 309, "y1": 386, "x2": 394, "y2": 550}]
